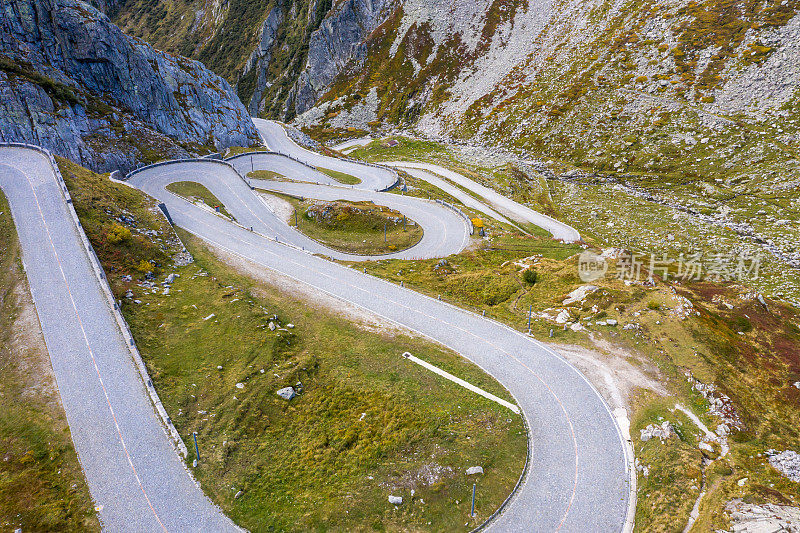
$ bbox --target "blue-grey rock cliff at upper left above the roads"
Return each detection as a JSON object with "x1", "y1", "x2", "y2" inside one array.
[{"x1": 0, "y1": 0, "x2": 258, "y2": 170}]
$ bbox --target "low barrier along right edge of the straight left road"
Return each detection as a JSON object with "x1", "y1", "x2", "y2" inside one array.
[{"x1": 0, "y1": 143, "x2": 187, "y2": 457}]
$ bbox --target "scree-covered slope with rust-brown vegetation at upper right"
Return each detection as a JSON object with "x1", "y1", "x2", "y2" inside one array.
[{"x1": 308, "y1": 0, "x2": 800, "y2": 187}]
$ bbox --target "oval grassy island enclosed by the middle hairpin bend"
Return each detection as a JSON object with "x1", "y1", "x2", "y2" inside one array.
[{"x1": 281, "y1": 195, "x2": 423, "y2": 255}]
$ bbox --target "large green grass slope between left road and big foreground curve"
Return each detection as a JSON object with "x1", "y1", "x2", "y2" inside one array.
[{"x1": 123, "y1": 234, "x2": 526, "y2": 531}]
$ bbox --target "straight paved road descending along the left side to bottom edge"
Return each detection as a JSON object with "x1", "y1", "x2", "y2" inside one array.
[{"x1": 0, "y1": 146, "x2": 238, "y2": 532}]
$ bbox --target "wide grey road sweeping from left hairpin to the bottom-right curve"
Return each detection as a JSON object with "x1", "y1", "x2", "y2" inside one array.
[{"x1": 129, "y1": 137, "x2": 631, "y2": 532}]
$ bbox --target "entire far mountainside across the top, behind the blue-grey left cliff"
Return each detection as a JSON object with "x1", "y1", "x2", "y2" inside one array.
[{"x1": 113, "y1": 0, "x2": 800, "y2": 181}]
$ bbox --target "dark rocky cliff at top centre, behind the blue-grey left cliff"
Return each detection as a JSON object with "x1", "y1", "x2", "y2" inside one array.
[{"x1": 109, "y1": 0, "x2": 399, "y2": 119}]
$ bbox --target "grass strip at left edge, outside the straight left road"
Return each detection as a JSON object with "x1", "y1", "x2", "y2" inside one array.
[{"x1": 0, "y1": 192, "x2": 100, "y2": 531}]
